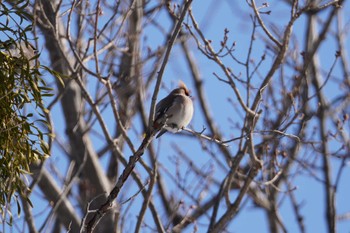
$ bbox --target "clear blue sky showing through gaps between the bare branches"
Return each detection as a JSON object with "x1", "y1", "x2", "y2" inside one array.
[{"x1": 1, "y1": 0, "x2": 350, "y2": 233}]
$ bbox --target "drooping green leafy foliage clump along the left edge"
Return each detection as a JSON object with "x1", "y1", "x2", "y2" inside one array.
[{"x1": 0, "y1": 1, "x2": 51, "y2": 214}]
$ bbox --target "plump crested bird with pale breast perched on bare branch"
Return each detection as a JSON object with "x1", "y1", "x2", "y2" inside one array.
[{"x1": 154, "y1": 82, "x2": 193, "y2": 138}]
